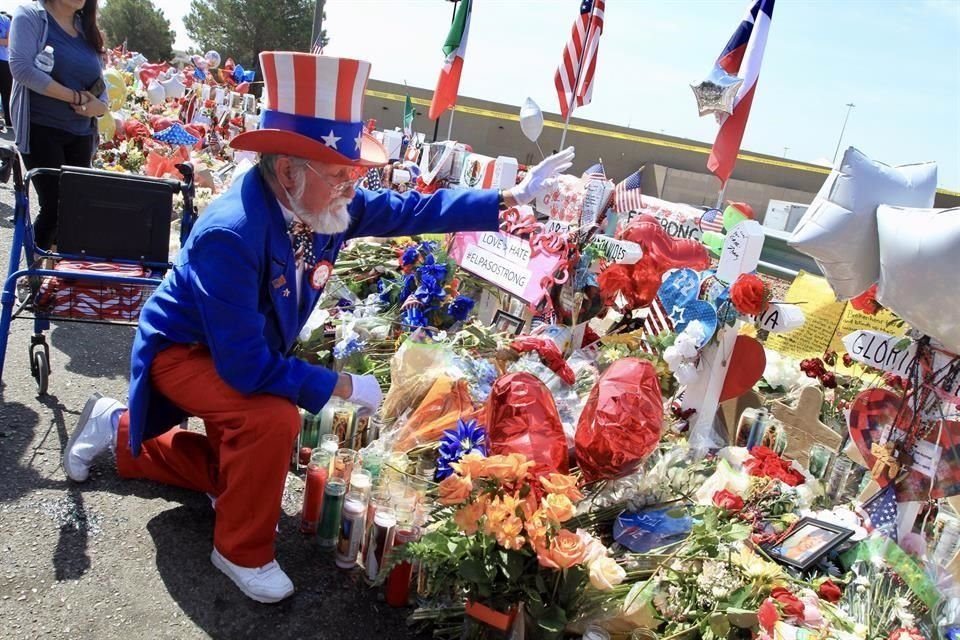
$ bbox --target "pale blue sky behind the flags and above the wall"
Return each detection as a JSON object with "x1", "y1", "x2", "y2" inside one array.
[{"x1": 0, "y1": 0, "x2": 960, "y2": 191}]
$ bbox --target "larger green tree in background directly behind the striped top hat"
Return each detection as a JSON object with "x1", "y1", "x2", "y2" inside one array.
[{"x1": 183, "y1": 0, "x2": 326, "y2": 74}]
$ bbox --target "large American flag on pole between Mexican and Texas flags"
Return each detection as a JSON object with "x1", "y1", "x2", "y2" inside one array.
[{"x1": 554, "y1": 0, "x2": 605, "y2": 118}]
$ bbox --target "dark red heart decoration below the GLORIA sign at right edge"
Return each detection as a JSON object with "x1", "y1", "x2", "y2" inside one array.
[{"x1": 849, "y1": 389, "x2": 960, "y2": 502}]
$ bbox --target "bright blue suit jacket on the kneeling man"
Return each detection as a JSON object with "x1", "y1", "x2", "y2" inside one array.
[{"x1": 130, "y1": 170, "x2": 499, "y2": 455}]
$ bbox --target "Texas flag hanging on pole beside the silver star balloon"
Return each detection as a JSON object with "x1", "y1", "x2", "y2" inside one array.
[{"x1": 707, "y1": 0, "x2": 774, "y2": 184}]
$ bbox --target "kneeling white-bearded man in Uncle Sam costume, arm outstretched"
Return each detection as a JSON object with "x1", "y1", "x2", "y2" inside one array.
[{"x1": 63, "y1": 52, "x2": 573, "y2": 602}]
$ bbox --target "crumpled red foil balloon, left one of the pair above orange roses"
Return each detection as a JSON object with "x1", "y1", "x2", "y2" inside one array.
[{"x1": 481, "y1": 372, "x2": 568, "y2": 475}]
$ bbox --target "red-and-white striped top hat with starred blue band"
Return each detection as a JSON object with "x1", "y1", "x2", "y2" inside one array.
[{"x1": 230, "y1": 51, "x2": 388, "y2": 167}]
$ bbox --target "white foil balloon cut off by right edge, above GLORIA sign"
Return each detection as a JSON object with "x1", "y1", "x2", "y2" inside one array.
[{"x1": 877, "y1": 206, "x2": 960, "y2": 353}]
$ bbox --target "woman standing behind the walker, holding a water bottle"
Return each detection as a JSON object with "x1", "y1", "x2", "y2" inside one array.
[{"x1": 10, "y1": 0, "x2": 107, "y2": 249}]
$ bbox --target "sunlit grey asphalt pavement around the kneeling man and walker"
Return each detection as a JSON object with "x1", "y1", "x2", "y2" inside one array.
[{"x1": 0, "y1": 133, "x2": 417, "y2": 640}]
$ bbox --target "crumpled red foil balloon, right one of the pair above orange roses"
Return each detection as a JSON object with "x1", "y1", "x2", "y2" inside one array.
[{"x1": 575, "y1": 358, "x2": 663, "y2": 482}]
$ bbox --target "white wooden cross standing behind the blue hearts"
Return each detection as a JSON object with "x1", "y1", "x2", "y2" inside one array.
[{"x1": 683, "y1": 220, "x2": 765, "y2": 456}]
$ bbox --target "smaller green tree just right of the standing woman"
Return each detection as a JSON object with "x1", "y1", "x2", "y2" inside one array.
[{"x1": 99, "y1": 0, "x2": 176, "y2": 61}]
